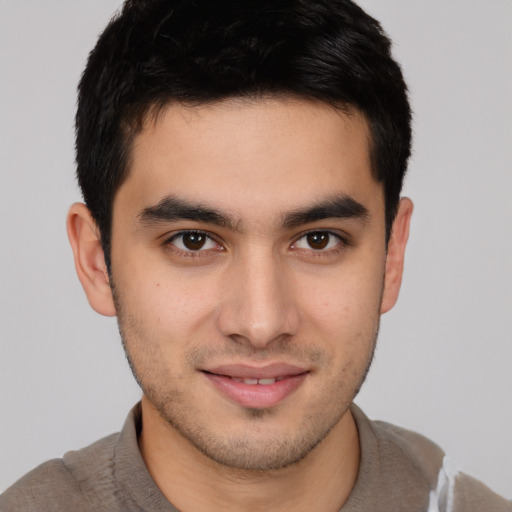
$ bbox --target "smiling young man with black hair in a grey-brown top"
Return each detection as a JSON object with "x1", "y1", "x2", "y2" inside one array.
[{"x1": 0, "y1": 1, "x2": 510, "y2": 511}]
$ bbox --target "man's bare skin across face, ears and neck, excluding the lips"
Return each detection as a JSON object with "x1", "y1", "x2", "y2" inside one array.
[{"x1": 68, "y1": 98, "x2": 412, "y2": 512}]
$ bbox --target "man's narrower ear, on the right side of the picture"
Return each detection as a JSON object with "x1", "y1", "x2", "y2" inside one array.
[{"x1": 380, "y1": 197, "x2": 413, "y2": 314}]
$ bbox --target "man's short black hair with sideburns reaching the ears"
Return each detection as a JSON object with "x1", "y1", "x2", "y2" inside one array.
[{"x1": 76, "y1": 0, "x2": 411, "y2": 268}]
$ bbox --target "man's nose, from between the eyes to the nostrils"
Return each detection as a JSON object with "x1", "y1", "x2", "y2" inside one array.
[{"x1": 218, "y1": 250, "x2": 299, "y2": 349}]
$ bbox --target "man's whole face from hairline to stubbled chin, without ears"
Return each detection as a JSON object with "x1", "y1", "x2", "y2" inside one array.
[{"x1": 107, "y1": 99, "x2": 386, "y2": 469}]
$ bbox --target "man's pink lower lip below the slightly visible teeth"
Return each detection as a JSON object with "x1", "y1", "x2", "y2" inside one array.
[{"x1": 203, "y1": 372, "x2": 307, "y2": 409}]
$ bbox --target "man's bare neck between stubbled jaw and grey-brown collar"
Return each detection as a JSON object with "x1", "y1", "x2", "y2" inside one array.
[{"x1": 139, "y1": 398, "x2": 360, "y2": 512}]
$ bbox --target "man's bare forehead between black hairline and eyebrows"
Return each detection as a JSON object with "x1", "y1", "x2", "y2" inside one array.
[{"x1": 118, "y1": 98, "x2": 383, "y2": 224}]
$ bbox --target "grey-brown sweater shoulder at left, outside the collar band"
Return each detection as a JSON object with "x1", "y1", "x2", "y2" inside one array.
[{"x1": 0, "y1": 434, "x2": 119, "y2": 512}]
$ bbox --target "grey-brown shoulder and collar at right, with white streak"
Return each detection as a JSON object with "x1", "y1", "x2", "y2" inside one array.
[{"x1": 352, "y1": 407, "x2": 512, "y2": 512}]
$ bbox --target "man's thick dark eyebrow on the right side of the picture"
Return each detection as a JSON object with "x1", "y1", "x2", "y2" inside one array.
[{"x1": 282, "y1": 195, "x2": 370, "y2": 229}]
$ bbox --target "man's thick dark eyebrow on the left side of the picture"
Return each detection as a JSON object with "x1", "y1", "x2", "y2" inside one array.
[{"x1": 137, "y1": 196, "x2": 237, "y2": 231}]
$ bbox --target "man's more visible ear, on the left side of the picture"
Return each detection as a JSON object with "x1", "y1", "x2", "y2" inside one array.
[{"x1": 66, "y1": 203, "x2": 116, "y2": 316}]
